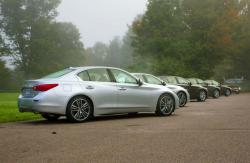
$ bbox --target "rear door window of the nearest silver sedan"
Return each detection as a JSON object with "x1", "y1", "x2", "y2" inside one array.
[{"x1": 88, "y1": 68, "x2": 111, "y2": 82}]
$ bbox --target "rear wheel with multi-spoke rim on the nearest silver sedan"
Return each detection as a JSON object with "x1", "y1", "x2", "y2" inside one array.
[{"x1": 66, "y1": 96, "x2": 93, "y2": 122}]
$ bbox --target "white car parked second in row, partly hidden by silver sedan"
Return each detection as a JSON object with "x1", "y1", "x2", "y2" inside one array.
[{"x1": 132, "y1": 73, "x2": 190, "y2": 107}]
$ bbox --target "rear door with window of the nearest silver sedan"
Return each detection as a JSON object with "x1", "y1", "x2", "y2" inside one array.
[{"x1": 78, "y1": 68, "x2": 118, "y2": 114}]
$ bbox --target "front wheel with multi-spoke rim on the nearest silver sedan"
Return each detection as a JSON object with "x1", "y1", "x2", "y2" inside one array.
[{"x1": 155, "y1": 93, "x2": 175, "y2": 116}]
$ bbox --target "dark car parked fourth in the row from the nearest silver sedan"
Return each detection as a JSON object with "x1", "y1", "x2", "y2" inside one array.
[{"x1": 188, "y1": 78, "x2": 221, "y2": 98}]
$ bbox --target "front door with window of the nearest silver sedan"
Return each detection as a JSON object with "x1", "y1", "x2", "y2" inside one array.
[{"x1": 110, "y1": 69, "x2": 152, "y2": 112}]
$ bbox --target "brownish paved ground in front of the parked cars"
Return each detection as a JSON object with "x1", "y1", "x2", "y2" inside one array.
[{"x1": 0, "y1": 94, "x2": 250, "y2": 163}]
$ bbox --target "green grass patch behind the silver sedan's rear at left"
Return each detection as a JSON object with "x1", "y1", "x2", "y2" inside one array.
[{"x1": 0, "y1": 93, "x2": 41, "y2": 123}]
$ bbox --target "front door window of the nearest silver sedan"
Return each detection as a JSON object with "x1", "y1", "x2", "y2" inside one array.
[{"x1": 111, "y1": 69, "x2": 137, "y2": 84}]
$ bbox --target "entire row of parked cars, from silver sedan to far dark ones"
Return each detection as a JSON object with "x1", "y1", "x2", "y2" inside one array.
[{"x1": 18, "y1": 67, "x2": 240, "y2": 122}]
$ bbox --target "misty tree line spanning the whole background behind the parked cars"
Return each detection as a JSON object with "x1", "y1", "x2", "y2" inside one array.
[{"x1": 0, "y1": 0, "x2": 250, "y2": 90}]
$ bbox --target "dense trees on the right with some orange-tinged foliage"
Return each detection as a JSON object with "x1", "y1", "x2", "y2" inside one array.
[{"x1": 133, "y1": 0, "x2": 250, "y2": 79}]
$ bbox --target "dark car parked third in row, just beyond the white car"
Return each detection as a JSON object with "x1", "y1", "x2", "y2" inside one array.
[{"x1": 160, "y1": 76, "x2": 208, "y2": 102}]
